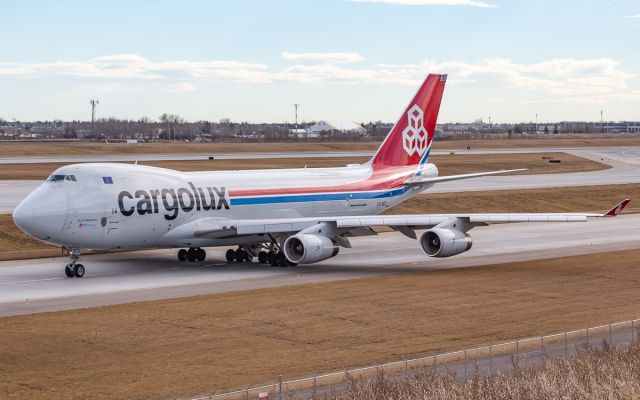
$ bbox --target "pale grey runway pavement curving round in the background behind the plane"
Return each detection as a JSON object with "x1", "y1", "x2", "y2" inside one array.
[{"x1": 0, "y1": 147, "x2": 640, "y2": 213}]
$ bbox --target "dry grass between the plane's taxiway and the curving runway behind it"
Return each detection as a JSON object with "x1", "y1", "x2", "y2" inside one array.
[{"x1": 0, "y1": 184, "x2": 640, "y2": 260}]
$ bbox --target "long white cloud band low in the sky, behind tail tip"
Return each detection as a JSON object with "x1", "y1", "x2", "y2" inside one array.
[{"x1": 0, "y1": 52, "x2": 638, "y2": 102}]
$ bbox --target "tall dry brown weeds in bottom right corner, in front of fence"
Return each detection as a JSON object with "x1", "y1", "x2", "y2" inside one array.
[{"x1": 328, "y1": 342, "x2": 640, "y2": 400}]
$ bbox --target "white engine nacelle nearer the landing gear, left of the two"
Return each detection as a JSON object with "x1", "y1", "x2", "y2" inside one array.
[{"x1": 283, "y1": 233, "x2": 340, "y2": 264}]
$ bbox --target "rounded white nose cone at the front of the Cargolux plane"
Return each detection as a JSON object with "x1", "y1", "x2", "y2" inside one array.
[{"x1": 13, "y1": 184, "x2": 68, "y2": 240}]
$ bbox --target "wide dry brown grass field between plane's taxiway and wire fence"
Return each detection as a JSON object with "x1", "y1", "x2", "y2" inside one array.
[{"x1": 0, "y1": 250, "x2": 640, "y2": 399}]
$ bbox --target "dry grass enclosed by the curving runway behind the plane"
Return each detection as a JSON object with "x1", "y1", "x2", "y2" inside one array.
[{"x1": 0, "y1": 153, "x2": 608, "y2": 180}]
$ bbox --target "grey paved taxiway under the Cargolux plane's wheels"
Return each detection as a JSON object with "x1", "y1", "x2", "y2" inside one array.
[{"x1": 0, "y1": 215, "x2": 640, "y2": 316}]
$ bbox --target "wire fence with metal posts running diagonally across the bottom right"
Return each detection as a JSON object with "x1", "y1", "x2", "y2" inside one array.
[{"x1": 191, "y1": 319, "x2": 640, "y2": 400}]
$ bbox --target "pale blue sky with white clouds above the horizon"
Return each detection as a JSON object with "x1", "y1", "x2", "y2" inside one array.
[{"x1": 0, "y1": 0, "x2": 640, "y2": 122}]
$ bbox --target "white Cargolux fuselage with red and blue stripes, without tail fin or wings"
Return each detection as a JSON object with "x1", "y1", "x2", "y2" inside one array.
[{"x1": 14, "y1": 163, "x2": 438, "y2": 249}]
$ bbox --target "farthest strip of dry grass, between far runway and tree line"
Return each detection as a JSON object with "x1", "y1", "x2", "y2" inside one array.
[{"x1": 0, "y1": 134, "x2": 640, "y2": 157}]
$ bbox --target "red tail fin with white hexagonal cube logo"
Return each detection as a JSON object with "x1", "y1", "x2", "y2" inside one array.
[{"x1": 371, "y1": 74, "x2": 447, "y2": 170}]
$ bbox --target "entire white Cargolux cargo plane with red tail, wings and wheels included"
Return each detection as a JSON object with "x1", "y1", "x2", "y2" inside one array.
[{"x1": 13, "y1": 75, "x2": 628, "y2": 277}]
